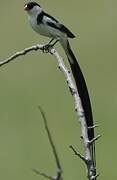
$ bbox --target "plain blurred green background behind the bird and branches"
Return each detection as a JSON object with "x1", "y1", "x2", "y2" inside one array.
[{"x1": 0, "y1": 0, "x2": 117, "y2": 180}]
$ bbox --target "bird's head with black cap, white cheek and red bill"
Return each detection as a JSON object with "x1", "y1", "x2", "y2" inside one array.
[{"x1": 24, "y1": 2, "x2": 42, "y2": 15}]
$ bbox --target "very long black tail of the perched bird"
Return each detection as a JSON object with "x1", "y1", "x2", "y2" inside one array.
[{"x1": 61, "y1": 40, "x2": 96, "y2": 170}]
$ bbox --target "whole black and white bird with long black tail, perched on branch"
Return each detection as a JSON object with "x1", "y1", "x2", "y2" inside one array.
[{"x1": 24, "y1": 2, "x2": 95, "y2": 170}]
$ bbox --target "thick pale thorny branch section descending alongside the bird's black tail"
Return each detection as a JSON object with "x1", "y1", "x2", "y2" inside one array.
[{"x1": 51, "y1": 48, "x2": 97, "y2": 180}]
